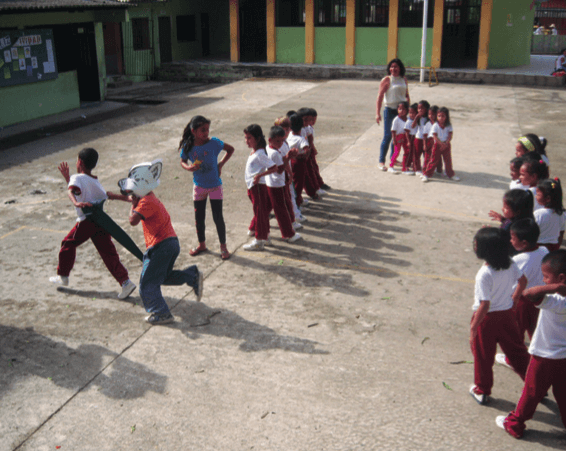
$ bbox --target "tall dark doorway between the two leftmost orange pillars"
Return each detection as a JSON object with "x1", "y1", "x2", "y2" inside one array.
[{"x1": 240, "y1": 0, "x2": 267, "y2": 62}]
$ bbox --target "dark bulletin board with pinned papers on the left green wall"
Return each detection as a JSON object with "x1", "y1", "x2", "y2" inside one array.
[{"x1": 0, "y1": 29, "x2": 59, "y2": 87}]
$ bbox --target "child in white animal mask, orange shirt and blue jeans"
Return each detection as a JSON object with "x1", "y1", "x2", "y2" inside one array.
[{"x1": 118, "y1": 160, "x2": 204, "y2": 326}]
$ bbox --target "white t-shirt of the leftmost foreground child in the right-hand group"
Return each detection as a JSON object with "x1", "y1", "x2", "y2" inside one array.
[{"x1": 472, "y1": 261, "x2": 523, "y2": 312}]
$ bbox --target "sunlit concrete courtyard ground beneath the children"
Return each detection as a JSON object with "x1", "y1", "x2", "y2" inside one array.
[{"x1": 0, "y1": 79, "x2": 566, "y2": 451}]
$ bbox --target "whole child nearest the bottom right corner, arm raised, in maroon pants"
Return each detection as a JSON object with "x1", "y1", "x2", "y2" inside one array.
[{"x1": 495, "y1": 249, "x2": 566, "y2": 438}]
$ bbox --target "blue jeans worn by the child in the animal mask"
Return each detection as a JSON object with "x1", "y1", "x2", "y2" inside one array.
[{"x1": 139, "y1": 237, "x2": 198, "y2": 315}]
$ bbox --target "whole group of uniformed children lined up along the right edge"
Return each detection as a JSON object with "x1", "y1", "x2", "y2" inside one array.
[{"x1": 470, "y1": 134, "x2": 566, "y2": 438}]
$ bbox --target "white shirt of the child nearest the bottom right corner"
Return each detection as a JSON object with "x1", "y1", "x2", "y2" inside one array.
[{"x1": 529, "y1": 294, "x2": 566, "y2": 360}]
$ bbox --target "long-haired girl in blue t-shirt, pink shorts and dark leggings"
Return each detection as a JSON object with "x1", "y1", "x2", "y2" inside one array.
[{"x1": 179, "y1": 116, "x2": 234, "y2": 260}]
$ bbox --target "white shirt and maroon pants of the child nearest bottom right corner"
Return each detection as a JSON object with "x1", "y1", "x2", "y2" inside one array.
[{"x1": 503, "y1": 294, "x2": 566, "y2": 438}]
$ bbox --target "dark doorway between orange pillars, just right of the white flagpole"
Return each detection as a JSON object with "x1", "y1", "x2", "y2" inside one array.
[{"x1": 441, "y1": 0, "x2": 481, "y2": 68}]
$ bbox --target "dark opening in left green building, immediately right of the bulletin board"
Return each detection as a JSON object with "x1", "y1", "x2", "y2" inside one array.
[{"x1": 51, "y1": 23, "x2": 100, "y2": 101}]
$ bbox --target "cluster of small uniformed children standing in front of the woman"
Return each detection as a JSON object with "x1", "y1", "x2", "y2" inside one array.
[{"x1": 381, "y1": 100, "x2": 460, "y2": 183}]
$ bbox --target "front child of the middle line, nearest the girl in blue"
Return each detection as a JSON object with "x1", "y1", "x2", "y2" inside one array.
[{"x1": 244, "y1": 124, "x2": 277, "y2": 251}]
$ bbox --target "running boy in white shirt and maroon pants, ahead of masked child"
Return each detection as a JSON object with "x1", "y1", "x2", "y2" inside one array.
[{"x1": 49, "y1": 147, "x2": 136, "y2": 299}]
